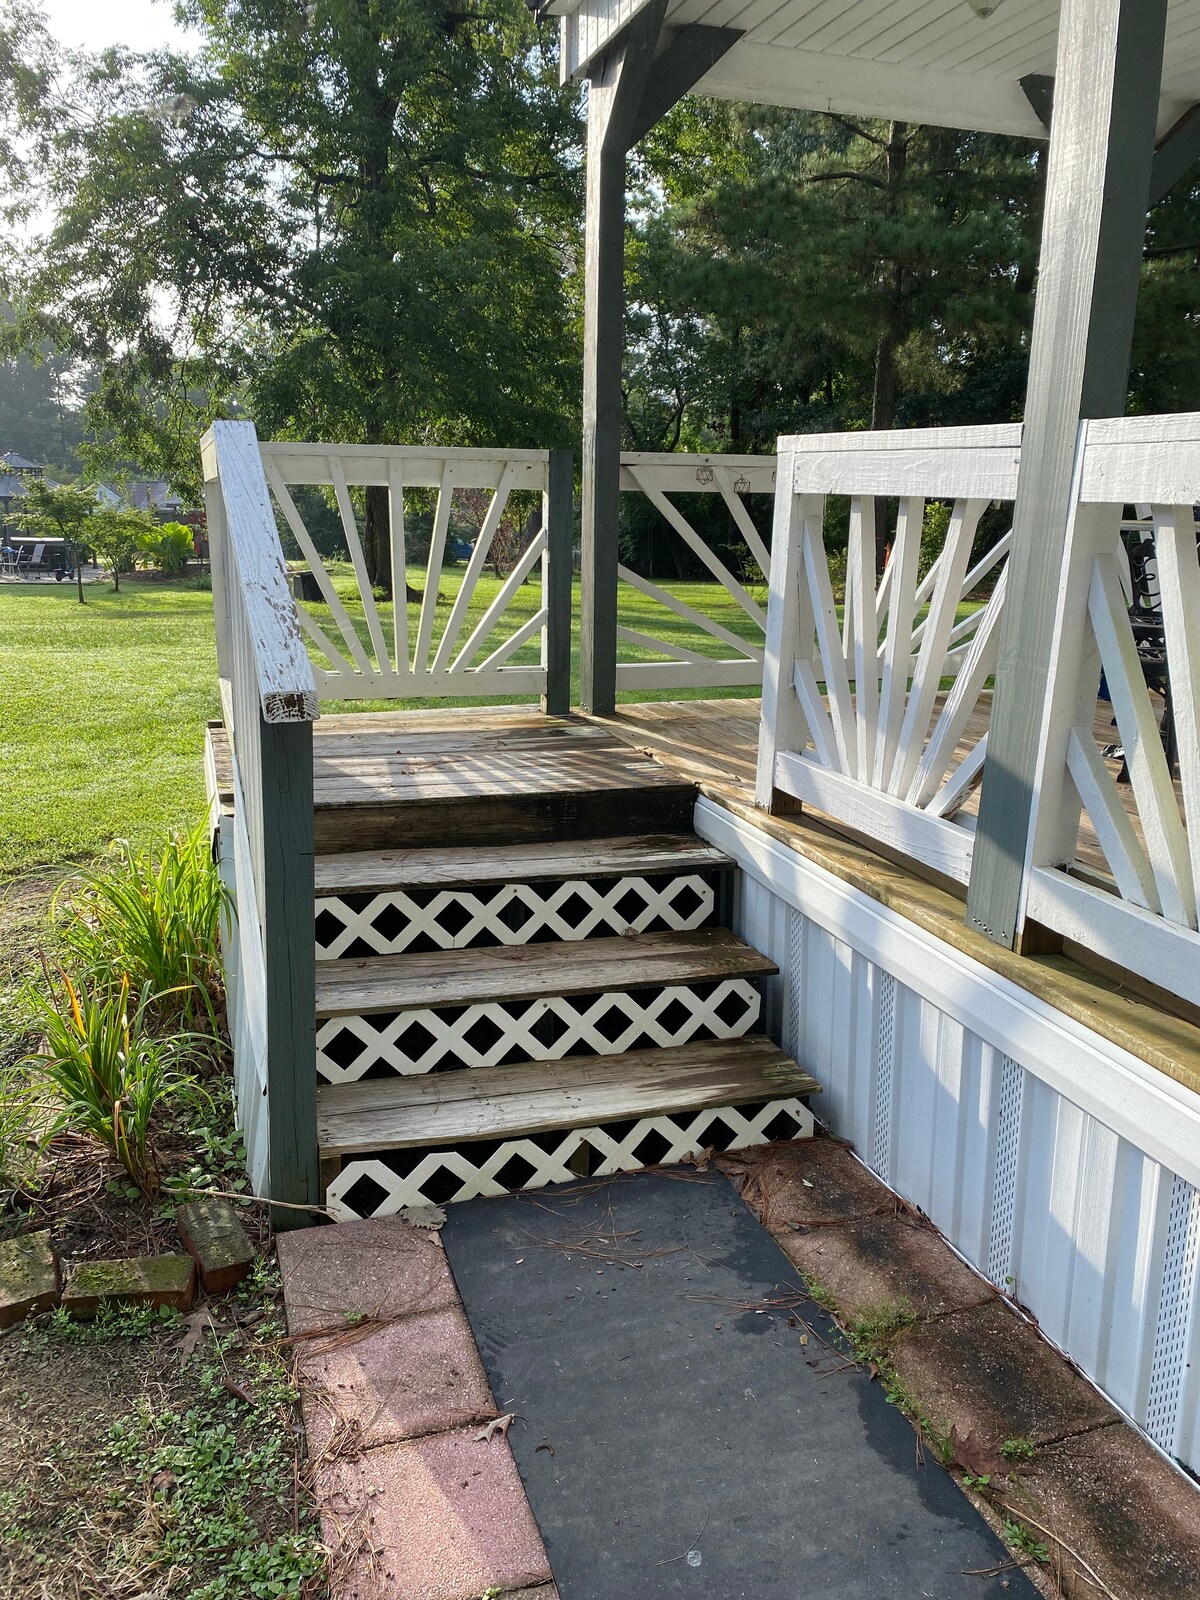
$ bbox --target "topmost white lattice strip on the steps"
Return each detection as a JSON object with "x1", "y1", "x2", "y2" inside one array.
[{"x1": 315, "y1": 874, "x2": 715, "y2": 960}]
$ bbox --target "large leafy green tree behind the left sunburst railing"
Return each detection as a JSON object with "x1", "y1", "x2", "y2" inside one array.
[{"x1": 0, "y1": 0, "x2": 581, "y2": 584}]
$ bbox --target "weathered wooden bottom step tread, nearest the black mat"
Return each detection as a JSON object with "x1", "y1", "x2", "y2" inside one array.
[{"x1": 317, "y1": 1035, "x2": 821, "y2": 1157}]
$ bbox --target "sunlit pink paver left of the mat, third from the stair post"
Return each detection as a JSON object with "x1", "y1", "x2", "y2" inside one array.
[{"x1": 315, "y1": 1429, "x2": 550, "y2": 1600}]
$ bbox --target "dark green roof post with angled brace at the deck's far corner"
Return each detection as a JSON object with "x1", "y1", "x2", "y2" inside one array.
[{"x1": 579, "y1": 10, "x2": 741, "y2": 717}]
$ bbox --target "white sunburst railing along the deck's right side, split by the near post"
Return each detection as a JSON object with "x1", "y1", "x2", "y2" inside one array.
[{"x1": 757, "y1": 413, "x2": 1200, "y2": 1005}]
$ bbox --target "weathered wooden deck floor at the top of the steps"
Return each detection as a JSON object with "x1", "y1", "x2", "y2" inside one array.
[{"x1": 210, "y1": 694, "x2": 1178, "y2": 882}]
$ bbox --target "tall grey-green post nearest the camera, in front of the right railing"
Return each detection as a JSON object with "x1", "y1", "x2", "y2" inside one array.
[{"x1": 966, "y1": 0, "x2": 1166, "y2": 947}]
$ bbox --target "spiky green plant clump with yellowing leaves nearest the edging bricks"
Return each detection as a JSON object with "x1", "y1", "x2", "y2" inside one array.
[{"x1": 29, "y1": 970, "x2": 187, "y2": 1195}]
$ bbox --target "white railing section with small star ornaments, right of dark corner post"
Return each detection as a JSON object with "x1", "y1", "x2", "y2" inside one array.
[{"x1": 616, "y1": 453, "x2": 776, "y2": 690}]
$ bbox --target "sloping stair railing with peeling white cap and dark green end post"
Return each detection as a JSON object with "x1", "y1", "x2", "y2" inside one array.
[{"x1": 202, "y1": 422, "x2": 320, "y2": 1203}]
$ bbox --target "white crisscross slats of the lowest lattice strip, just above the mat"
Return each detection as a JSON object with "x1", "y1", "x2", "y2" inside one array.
[{"x1": 326, "y1": 1099, "x2": 813, "y2": 1221}]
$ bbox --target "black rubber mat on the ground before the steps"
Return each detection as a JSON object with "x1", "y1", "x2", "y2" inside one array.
[{"x1": 442, "y1": 1168, "x2": 1035, "y2": 1600}]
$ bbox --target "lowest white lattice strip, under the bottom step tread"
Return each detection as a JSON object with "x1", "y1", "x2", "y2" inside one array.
[{"x1": 326, "y1": 1099, "x2": 813, "y2": 1221}]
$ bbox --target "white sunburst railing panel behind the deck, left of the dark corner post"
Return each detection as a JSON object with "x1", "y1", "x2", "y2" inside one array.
[{"x1": 261, "y1": 443, "x2": 571, "y2": 712}]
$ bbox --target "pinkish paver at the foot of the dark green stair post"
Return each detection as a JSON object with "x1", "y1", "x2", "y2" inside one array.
[{"x1": 278, "y1": 1218, "x2": 458, "y2": 1333}]
